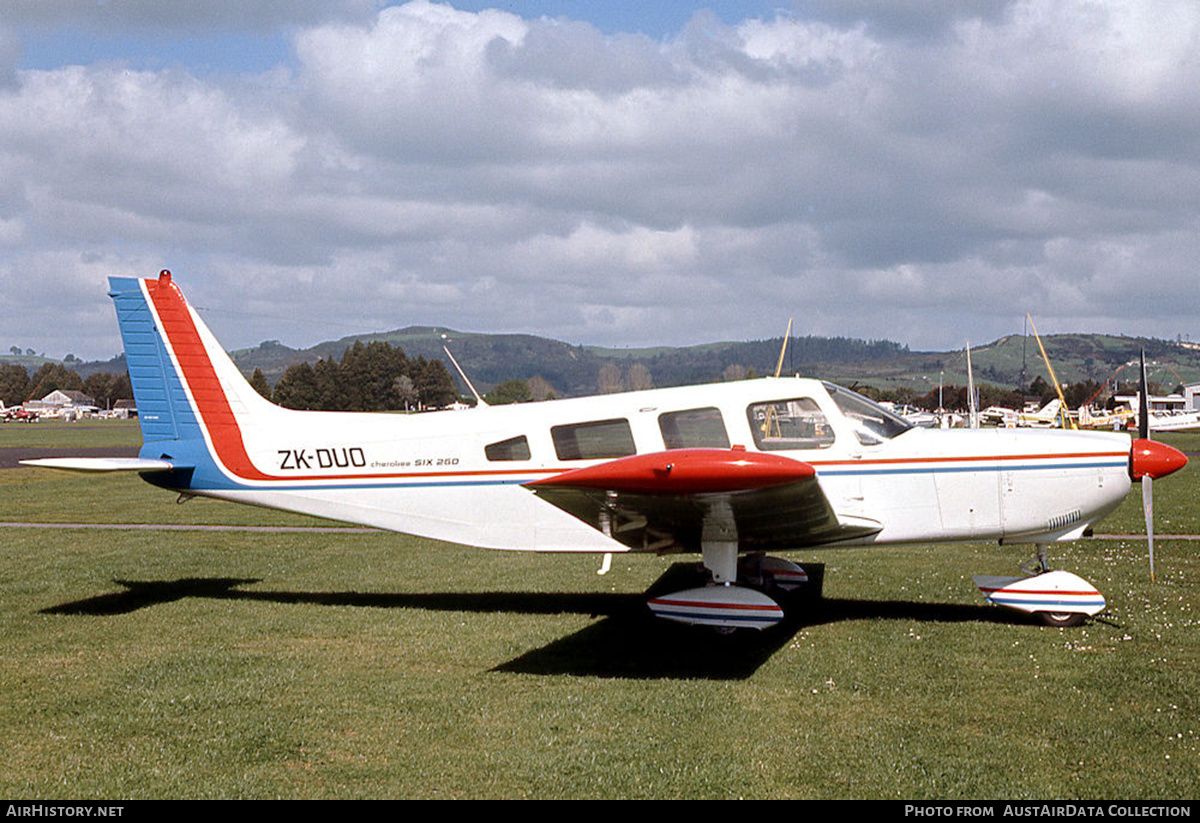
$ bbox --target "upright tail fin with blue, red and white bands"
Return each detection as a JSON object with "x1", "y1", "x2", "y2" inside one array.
[{"x1": 109, "y1": 270, "x2": 277, "y2": 476}]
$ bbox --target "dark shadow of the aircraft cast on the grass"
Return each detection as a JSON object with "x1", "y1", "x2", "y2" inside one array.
[{"x1": 41, "y1": 563, "x2": 1032, "y2": 680}]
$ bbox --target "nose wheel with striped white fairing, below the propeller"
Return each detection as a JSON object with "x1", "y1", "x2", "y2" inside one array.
[{"x1": 972, "y1": 543, "x2": 1106, "y2": 627}]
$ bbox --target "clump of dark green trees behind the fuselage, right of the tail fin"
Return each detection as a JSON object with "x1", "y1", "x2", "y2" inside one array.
[{"x1": 267, "y1": 341, "x2": 458, "y2": 412}]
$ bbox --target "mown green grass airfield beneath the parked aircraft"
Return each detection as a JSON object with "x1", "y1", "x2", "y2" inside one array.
[{"x1": 0, "y1": 426, "x2": 1200, "y2": 799}]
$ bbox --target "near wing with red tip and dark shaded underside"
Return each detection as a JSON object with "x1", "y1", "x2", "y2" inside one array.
[{"x1": 526, "y1": 449, "x2": 882, "y2": 552}]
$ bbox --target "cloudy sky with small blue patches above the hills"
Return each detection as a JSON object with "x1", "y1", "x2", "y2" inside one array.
[{"x1": 0, "y1": 0, "x2": 1200, "y2": 360}]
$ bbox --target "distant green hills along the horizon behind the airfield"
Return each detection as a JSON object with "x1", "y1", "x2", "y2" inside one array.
[{"x1": 7, "y1": 326, "x2": 1200, "y2": 397}]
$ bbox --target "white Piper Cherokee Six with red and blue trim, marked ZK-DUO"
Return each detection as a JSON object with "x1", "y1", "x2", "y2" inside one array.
[{"x1": 25, "y1": 271, "x2": 1187, "y2": 629}]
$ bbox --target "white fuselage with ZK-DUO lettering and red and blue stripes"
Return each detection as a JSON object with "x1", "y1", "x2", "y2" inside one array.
[{"x1": 180, "y1": 347, "x2": 1130, "y2": 552}]
